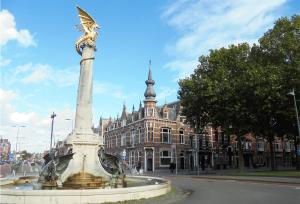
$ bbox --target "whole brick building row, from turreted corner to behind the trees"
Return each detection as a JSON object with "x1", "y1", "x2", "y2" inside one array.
[{"x1": 100, "y1": 64, "x2": 296, "y2": 171}]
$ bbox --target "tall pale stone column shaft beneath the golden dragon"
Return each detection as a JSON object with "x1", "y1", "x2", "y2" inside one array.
[{"x1": 75, "y1": 42, "x2": 95, "y2": 135}]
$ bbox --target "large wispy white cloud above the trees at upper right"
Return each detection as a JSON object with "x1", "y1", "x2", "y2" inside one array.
[{"x1": 161, "y1": 0, "x2": 287, "y2": 79}]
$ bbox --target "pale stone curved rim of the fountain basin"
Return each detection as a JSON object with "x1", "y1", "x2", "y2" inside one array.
[{"x1": 0, "y1": 176, "x2": 171, "y2": 204}]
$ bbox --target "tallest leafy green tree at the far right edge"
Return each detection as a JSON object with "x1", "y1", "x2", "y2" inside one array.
[{"x1": 251, "y1": 15, "x2": 300, "y2": 169}]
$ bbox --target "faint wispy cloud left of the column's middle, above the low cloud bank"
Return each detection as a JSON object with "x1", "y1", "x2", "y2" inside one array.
[{"x1": 11, "y1": 63, "x2": 79, "y2": 87}]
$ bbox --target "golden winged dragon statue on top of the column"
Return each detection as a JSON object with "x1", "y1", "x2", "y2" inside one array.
[{"x1": 75, "y1": 6, "x2": 100, "y2": 55}]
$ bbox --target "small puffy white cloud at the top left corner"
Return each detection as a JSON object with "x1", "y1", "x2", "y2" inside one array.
[{"x1": 0, "y1": 9, "x2": 36, "y2": 47}]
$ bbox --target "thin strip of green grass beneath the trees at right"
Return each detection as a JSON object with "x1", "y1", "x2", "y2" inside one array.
[{"x1": 226, "y1": 170, "x2": 300, "y2": 178}]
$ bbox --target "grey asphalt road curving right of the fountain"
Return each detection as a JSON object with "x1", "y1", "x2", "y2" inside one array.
[{"x1": 169, "y1": 177, "x2": 300, "y2": 204}]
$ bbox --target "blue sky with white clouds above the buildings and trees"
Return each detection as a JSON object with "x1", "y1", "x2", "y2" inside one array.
[{"x1": 0, "y1": 0, "x2": 300, "y2": 152}]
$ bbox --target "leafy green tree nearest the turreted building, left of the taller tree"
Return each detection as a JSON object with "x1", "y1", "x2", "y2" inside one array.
[{"x1": 178, "y1": 43, "x2": 253, "y2": 171}]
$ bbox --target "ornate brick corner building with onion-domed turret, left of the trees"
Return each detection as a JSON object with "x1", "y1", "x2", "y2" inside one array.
[{"x1": 98, "y1": 67, "x2": 197, "y2": 171}]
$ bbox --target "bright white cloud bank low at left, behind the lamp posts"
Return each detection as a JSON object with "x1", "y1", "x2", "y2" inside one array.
[{"x1": 0, "y1": 88, "x2": 75, "y2": 152}]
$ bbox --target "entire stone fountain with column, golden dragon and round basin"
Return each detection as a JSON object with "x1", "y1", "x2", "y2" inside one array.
[{"x1": 0, "y1": 7, "x2": 170, "y2": 203}]
